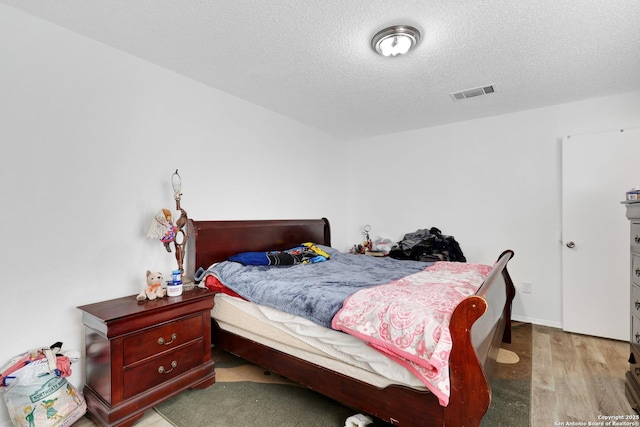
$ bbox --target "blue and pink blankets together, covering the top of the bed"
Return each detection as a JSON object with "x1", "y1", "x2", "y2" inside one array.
[{"x1": 202, "y1": 247, "x2": 491, "y2": 406}]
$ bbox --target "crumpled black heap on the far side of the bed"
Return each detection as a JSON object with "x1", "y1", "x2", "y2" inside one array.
[{"x1": 389, "y1": 227, "x2": 467, "y2": 262}]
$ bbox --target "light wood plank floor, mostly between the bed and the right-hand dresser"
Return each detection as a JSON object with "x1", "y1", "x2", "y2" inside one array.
[{"x1": 74, "y1": 325, "x2": 635, "y2": 427}]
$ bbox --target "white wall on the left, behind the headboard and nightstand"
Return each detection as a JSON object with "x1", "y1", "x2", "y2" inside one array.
[{"x1": 0, "y1": 5, "x2": 347, "y2": 424}]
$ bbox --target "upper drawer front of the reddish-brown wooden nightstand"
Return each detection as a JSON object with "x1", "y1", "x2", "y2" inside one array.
[{"x1": 124, "y1": 316, "x2": 203, "y2": 366}]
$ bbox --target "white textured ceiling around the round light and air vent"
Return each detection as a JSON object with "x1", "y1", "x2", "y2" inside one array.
[{"x1": 0, "y1": 0, "x2": 640, "y2": 140}]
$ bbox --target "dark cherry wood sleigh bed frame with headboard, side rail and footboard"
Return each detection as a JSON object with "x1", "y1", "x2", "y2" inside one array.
[{"x1": 186, "y1": 218, "x2": 515, "y2": 427}]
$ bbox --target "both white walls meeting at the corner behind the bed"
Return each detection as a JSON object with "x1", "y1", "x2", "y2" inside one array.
[{"x1": 0, "y1": 5, "x2": 640, "y2": 424}]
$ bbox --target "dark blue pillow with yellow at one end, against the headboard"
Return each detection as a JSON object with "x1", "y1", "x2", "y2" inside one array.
[{"x1": 229, "y1": 242, "x2": 329, "y2": 266}]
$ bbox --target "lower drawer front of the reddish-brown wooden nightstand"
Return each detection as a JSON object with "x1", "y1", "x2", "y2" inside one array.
[{"x1": 123, "y1": 341, "x2": 202, "y2": 399}]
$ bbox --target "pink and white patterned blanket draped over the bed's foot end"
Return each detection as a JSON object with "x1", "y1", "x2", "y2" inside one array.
[{"x1": 332, "y1": 262, "x2": 492, "y2": 406}]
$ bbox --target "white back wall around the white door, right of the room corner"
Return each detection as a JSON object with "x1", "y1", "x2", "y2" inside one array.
[{"x1": 348, "y1": 92, "x2": 640, "y2": 327}]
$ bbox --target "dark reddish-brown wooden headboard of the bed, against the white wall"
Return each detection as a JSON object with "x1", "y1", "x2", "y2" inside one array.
[{"x1": 185, "y1": 218, "x2": 331, "y2": 278}]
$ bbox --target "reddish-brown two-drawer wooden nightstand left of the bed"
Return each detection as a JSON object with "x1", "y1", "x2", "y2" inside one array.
[{"x1": 78, "y1": 288, "x2": 215, "y2": 426}]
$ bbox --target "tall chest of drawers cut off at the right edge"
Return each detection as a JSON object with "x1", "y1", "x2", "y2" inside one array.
[{"x1": 623, "y1": 200, "x2": 640, "y2": 411}]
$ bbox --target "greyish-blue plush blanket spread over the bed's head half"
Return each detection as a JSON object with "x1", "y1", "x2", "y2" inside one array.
[{"x1": 203, "y1": 245, "x2": 433, "y2": 328}]
